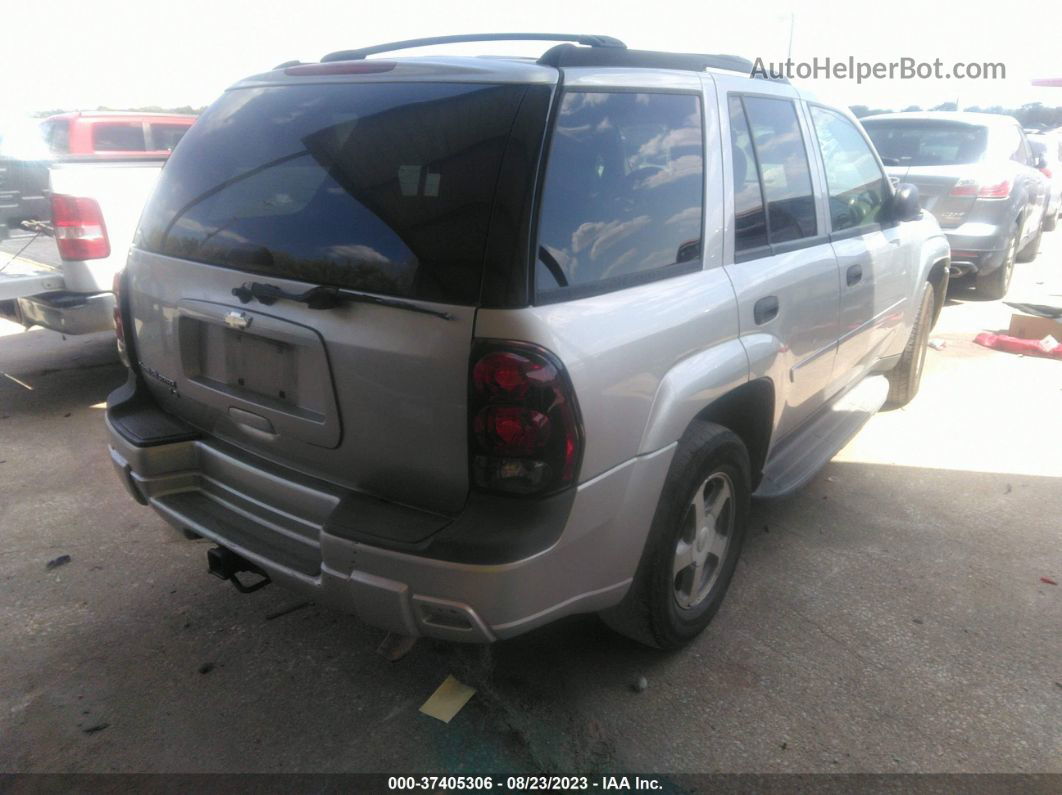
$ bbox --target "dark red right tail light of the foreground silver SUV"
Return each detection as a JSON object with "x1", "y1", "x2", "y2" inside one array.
[{"x1": 468, "y1": 341, "x2": 583, "y2": 496}]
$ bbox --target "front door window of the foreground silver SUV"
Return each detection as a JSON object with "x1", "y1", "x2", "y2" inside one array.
[{"x1": 811, "y1": 106, "x2": 888, "y2": 231}]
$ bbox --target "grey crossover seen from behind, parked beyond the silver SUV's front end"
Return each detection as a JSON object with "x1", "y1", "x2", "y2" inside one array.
[{"x1": 861, "y1": 113, "x2": 1048, "y2": 298}]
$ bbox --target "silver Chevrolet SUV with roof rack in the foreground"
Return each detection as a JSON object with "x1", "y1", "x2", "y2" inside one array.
[{"x1": 106, "y1": 35, "x2": 948, "y2": 646}]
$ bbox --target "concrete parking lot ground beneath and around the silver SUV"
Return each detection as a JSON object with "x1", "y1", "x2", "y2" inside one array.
[{"x1": 0, "y1": 238, "x2": 1062, "y2": 773}]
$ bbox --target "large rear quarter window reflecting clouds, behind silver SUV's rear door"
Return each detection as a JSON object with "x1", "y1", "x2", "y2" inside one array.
[{"x1": 535, "y1": 91, "x2": 704, "y2": 292}]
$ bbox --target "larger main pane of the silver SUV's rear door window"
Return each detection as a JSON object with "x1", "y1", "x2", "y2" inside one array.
[{"x1": 743, "y1": 97, "x2": 818, "y2": 243}]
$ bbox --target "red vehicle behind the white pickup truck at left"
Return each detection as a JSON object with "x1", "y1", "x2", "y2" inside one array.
[{"x1": 42, "y1": 110, "x2": 195, "y2": 157}]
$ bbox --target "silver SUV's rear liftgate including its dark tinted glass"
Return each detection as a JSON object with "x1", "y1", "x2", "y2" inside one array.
[{"x1": 129, "y1": 82, "x2": 543, "y2": 513}]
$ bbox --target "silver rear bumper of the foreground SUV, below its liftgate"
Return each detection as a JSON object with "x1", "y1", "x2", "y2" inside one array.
[{"x1": 107, "y1": 405, "x2": 674, "y2": 642}]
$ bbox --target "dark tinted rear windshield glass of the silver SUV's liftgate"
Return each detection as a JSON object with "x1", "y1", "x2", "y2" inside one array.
[{"x1": 139, "y1": 83, "x2": 527, "y2": 303}]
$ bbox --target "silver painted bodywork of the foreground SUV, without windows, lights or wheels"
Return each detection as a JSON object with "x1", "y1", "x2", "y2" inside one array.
[{"x1": 112, "y1": 57, "x2": 948, "y2": 641}]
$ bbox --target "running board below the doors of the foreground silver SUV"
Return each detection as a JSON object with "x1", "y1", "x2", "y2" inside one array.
[{"x1": 753, "y1": 376, "x2": 889, "y2": 499}]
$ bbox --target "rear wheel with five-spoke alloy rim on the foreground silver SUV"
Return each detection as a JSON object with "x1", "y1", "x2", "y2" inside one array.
[{"x1": 601, "y1": 421, "x2": 752, "y2": 649}]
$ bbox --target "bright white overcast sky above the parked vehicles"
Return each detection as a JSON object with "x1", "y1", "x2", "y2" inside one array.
[{"x1": 0, "y1": 0, "x2": 1062, "y2": 119}]
